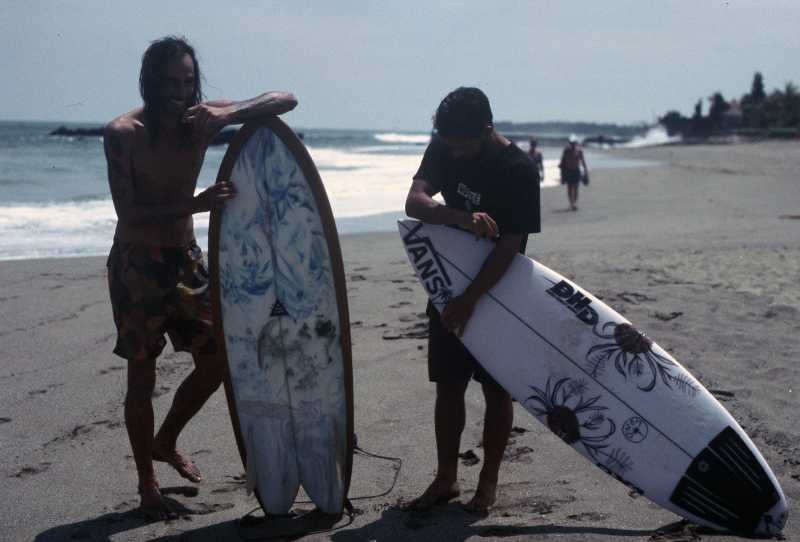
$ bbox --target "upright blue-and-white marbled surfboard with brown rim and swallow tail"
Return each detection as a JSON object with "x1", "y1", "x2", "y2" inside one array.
[{"x1": 209, "y1": 118, "x2": 353, "y2": 515}]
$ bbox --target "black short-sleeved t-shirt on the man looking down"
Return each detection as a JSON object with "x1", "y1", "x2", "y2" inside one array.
[{"x1": 414, "y1": 137, "x2": 541, "y2": 253}]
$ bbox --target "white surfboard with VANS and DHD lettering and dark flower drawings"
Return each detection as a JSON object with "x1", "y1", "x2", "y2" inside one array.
[{"x1": 399, "y1": 220, "x2": 786, "y2": 535}]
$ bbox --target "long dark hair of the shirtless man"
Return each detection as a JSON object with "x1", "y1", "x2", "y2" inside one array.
[{"x1": 139, "y1": 36, "x2": 203, "y2": 145}]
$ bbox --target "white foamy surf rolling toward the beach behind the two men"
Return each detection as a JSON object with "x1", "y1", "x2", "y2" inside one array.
[{"x1": 0, "y1": 134, "x2": 644, "y2": 260}]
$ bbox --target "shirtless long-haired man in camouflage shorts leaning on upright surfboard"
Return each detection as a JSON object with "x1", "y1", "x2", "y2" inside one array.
[{"x1": 103, "y1": 36, "x2": 297, "y2": 519}]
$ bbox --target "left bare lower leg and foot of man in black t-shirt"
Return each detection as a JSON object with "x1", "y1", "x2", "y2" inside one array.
[{"x1": 409, "y1": 380, "x2": 469, "y2": 510}]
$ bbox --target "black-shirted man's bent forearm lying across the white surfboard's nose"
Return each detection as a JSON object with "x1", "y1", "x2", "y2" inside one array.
[{"x1": 406, "y1": 179, "x2": 499, "y2": 237}]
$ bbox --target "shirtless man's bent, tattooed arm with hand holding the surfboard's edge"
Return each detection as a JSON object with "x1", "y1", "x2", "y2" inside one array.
[{"x1": 103, "y1": 119, "x2": 235, "y2": 224}]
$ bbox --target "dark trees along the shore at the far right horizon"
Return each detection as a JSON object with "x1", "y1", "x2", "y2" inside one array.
[{"x1": 658, "y1": 72, "x2": 800, "y2": 137}]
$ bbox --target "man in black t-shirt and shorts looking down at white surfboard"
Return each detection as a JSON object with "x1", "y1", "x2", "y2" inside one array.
[{"x1": 406, "y1": 87, "x2": 540, "y2": 513}]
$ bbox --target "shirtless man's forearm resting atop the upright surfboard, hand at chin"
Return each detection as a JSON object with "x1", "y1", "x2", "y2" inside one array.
[{"x1": 183, "y1": 92, "x2": 297, "y2": 137}]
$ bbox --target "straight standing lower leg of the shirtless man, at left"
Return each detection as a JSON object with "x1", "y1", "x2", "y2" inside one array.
[{"x1": 125, "y1": 359, "x2": 169, "y2": 519}]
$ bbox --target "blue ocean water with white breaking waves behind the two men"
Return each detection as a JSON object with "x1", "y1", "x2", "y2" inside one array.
[{"x1": 0, "y1": 121, "x2": 660, "y2": 260}]
